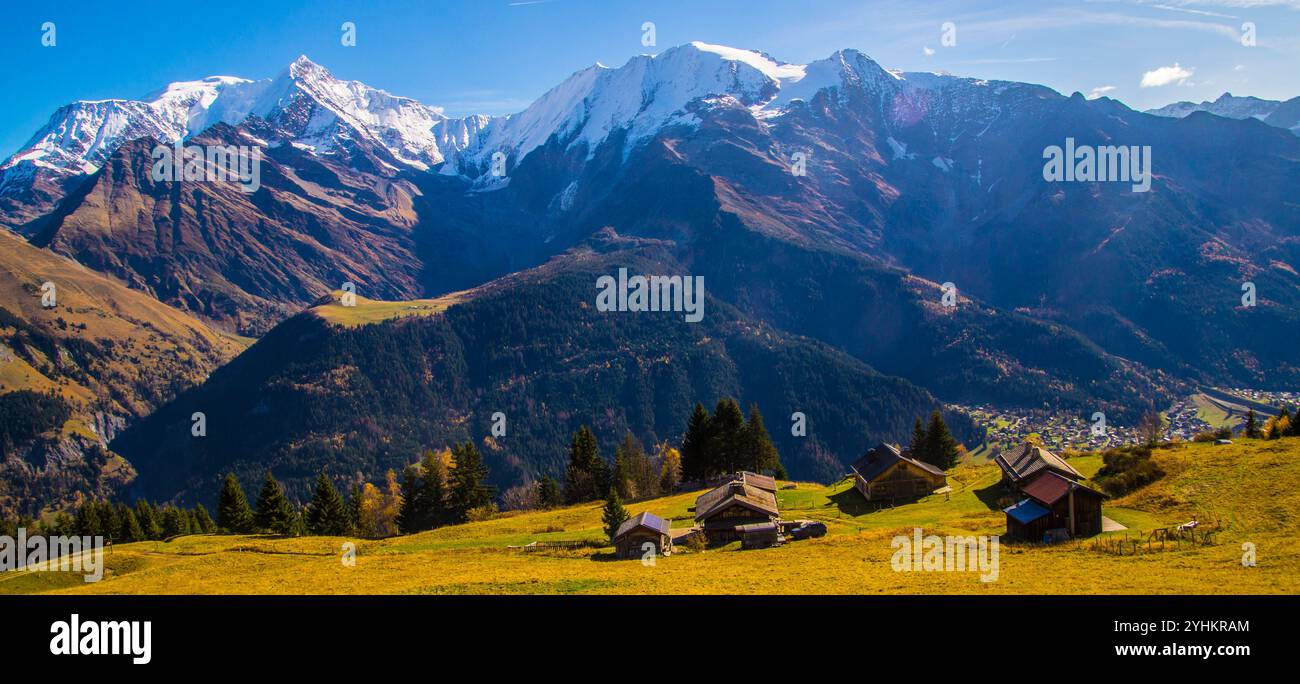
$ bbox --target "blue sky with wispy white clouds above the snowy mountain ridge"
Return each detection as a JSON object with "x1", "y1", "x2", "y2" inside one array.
[{"x1": 0, "y1": 0, "x2": 1300, "y2": 157}]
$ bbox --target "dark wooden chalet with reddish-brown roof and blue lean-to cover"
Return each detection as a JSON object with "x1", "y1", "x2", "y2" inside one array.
[{"x1": 1004, "y1": 471, "x2": 1106, "y2": 541}]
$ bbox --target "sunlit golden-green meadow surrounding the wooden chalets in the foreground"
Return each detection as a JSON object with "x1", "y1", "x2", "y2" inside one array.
[{"x1": 0, "y1": 438, "x2": 1300, "y2": 594}]
